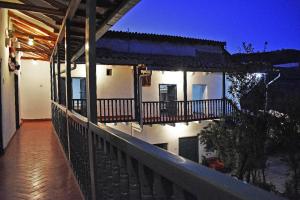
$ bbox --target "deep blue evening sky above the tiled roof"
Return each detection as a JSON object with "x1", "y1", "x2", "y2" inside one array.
[{"x1": 113, "y1": 0, "x2": 300, "y2": 53}]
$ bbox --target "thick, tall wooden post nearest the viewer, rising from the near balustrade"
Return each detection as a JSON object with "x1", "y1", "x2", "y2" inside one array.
[{"x1": 85, "y1": 0, "x2": 97, "y2": 200}]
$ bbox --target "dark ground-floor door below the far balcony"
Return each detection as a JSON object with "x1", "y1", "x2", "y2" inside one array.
[{"x1": 179, "y1": 136, "x2": 199, "y2": 163}]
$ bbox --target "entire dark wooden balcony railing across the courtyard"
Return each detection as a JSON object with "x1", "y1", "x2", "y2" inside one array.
[{"x1": 72, "y1": 98, "x2": 234, "y2": 124}]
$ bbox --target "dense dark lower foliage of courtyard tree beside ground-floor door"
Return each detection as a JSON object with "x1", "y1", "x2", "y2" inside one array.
[{"x1": 200, "y1": 112, "x2": 269, "y2": 186}]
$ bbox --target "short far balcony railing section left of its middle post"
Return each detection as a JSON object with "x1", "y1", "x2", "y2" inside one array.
[{"x1": 97, "y1": 98, "x2": 135, "y2": 123}]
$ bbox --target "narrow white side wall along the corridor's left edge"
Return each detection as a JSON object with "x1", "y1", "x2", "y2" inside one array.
[{"x1": 0, "y1": 8, "x2": 16, "y2": 148}]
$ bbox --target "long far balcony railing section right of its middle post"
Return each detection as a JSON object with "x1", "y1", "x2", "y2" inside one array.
[{"x1": 142, "y1": 99, "x2": 234, "y2": 124}]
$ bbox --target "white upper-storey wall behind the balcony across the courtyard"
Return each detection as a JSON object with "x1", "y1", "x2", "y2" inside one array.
[{"x1": 70, "y1": 65, "x2": 222, "y2": 101}]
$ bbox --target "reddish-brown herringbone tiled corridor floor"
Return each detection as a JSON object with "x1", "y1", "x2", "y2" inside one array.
[{"x1": 0, "y1": 122, "x2": 81, "y2": 200}]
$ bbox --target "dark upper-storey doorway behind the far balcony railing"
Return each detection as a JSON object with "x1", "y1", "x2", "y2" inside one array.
[{"x1": 159, "y1": 84, "x2": 177, "y2": 116}]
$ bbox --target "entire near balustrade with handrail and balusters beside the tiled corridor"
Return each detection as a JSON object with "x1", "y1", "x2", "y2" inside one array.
[{"x1": 52, "y1": 103, "x2": 279, "y2": 200}]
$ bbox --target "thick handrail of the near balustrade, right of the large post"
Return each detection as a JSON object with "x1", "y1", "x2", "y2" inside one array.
[{"x1": 89, "y1": 123, "x2": 281, "y2": 200}]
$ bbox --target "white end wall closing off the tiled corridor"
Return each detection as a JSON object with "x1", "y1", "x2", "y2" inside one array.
[{"x1": 20, "y1": 60, "x2": 51, "y2": 119}]
